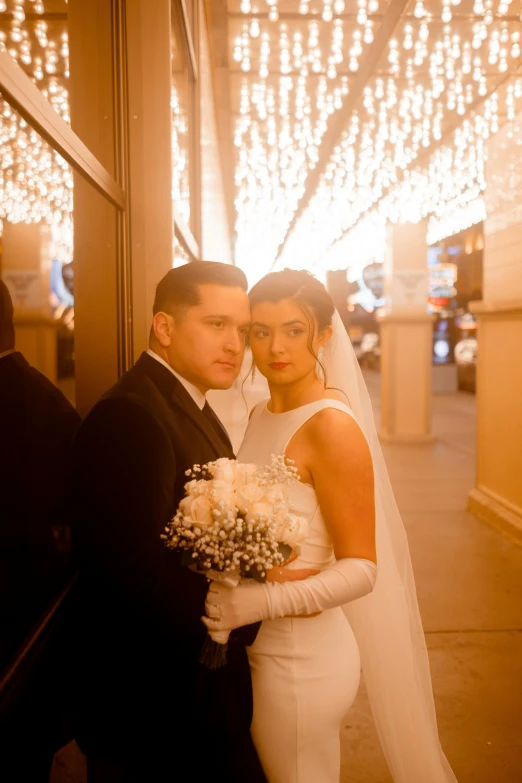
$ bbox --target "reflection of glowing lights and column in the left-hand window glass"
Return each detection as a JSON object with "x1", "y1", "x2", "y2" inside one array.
[{"x1": 0, "y1": 0, "x2": 74, "y2": 401}]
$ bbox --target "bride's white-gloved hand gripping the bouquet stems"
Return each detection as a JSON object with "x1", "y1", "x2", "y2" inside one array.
[{"x1": 201, "y1": 581, "x2": 270, "y2": 631}]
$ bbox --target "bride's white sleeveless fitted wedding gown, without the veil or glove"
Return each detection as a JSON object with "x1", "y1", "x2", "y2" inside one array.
[{"x1": 238, "y1": 399, "x2": 360, "y2": 783}]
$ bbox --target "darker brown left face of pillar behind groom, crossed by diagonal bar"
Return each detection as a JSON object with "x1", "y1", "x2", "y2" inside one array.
[{"x1": 68, "y1": 0, "x2": 118, "y2": 416}]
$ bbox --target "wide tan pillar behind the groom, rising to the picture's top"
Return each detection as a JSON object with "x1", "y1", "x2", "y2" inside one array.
[{"x1": 69, "y1": 0, "x2": 173, "y2": 415}]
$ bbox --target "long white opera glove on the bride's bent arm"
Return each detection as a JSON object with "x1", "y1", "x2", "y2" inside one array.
[{"x1": 202, "y1": 557, "x2": 377, "y2": 630}]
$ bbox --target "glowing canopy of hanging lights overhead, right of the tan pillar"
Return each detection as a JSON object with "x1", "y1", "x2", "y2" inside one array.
[{"x1": 227, "y1": 0, "x2": 522, "y2": 278}]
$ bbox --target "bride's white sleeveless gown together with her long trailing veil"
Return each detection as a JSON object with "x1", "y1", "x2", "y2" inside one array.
[{"x1": 232, "y1": 313, "x2": 457, "y2": 783}]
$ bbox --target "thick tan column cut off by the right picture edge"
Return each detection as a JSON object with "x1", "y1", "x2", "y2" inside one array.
[{"x1": 469, "y1": 115, "x2": 522, "y2": 543}]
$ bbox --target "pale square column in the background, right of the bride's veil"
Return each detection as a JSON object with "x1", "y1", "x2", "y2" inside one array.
[{"x1": 380, "y1": 220, "x2": 433, "y2": 443}]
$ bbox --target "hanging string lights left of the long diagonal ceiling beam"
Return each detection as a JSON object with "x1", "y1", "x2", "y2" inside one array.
[{"x1": 232, "y1": 0, "x2": 379, "y2": 272}]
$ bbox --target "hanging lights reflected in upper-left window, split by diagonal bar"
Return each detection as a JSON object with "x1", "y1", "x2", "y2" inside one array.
[{"x1": 0, "y1": 0, "x2": 73, "y2": 261}]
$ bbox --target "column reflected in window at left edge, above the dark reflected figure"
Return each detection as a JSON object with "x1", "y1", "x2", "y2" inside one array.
[{"x1": 2, "y1": 220, "x2": 58, "y2": 383}]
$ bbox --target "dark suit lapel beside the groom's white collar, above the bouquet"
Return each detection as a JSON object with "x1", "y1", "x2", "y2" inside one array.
[{"x1": 136, "y1": 353, "x2": 234, "y2": 459}]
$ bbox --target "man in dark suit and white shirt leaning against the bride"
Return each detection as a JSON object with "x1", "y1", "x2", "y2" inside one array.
[{"x1": 72, "y1": 262, "x2": 265, "y2": 783}]
